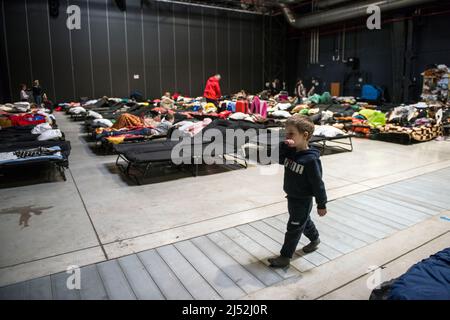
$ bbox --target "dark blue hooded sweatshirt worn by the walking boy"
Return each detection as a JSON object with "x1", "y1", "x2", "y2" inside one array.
[{"x1": 279, "y1": 142, "x2": 327, "y2": 209}]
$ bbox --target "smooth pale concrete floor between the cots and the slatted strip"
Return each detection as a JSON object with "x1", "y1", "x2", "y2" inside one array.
[{"x1": 0, "y1": 114, "x2": 450, "y2": 298}]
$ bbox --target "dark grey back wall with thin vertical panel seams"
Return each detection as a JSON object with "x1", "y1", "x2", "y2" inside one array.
[{"x1": 0, "y1": 0, "x2": 264, "y2": 102}]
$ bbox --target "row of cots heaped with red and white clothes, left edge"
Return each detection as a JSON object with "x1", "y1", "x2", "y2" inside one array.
[{"x1": 0, "y1": 102, "x2": 70, "y2": 180}]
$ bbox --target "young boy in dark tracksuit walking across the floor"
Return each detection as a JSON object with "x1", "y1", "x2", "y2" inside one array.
[{"x1": 269, "y1": 115, "x2": 327, "y2": 268}]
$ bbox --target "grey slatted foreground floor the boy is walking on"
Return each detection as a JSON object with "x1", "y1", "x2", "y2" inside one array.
[{"x1": 0, "y1": 168, "x2": 450, "y2": 300}]
